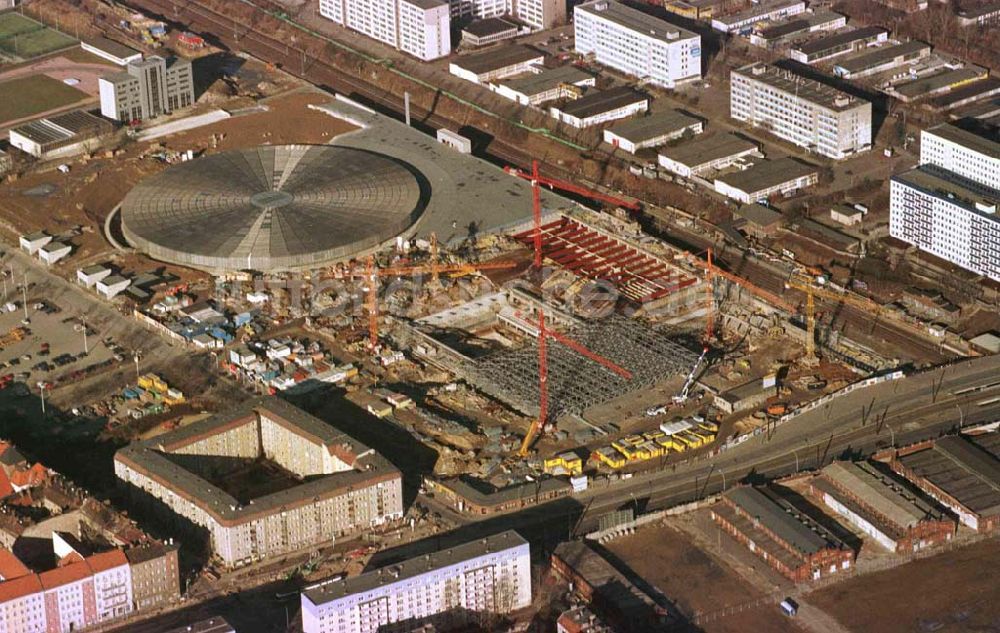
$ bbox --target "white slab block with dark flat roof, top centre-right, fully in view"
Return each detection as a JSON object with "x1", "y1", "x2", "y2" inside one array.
[{"x1": 573, "y1": 0, "x2": 701, "y2": 88}]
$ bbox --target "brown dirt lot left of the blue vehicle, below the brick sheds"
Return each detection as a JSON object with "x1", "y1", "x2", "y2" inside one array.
[{"x1": 606, "y1": 525, "x2": 804, "y2": 633}]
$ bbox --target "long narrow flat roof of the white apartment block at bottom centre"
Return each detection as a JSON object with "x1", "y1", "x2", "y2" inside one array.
[{"x1": 302, "y1": 530, "x2": 528, "y2": 605}]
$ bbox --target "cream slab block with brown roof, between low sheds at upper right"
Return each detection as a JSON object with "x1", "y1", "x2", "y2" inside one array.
[{"x1": 730, "y1": 63, "x2": 872, "y2": 159}]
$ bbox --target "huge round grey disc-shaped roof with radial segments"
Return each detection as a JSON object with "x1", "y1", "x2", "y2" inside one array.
[{"x1": 122, "y1": 145, "x2": 425, "y2": 271}]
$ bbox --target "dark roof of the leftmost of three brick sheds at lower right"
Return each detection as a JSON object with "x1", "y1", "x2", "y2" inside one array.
[{"x1": 723, "y1": 486, "x2": 846, "y2": 555}]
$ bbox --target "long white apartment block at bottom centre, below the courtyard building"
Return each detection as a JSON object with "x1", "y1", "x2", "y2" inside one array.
[{"x1": 302, "y1": 531, "x2": 531, "y2": 633}]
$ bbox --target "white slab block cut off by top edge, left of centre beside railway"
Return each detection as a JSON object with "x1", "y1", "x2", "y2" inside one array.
[{"x1": 319, "y1": 0, "x2": 451, "y2": 61}]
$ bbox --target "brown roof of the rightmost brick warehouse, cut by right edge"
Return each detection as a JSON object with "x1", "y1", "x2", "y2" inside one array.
[{"x1": 899, "y1": 435, "x2": 1000, "y2": 515}]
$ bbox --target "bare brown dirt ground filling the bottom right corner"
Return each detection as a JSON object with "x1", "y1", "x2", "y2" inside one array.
[{"x1": 808, "y1": 538, "x2": 1000, "y2": 633}]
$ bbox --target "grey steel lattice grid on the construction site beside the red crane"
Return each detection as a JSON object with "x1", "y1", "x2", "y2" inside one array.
[{"x1": 463, "y1": 316, "x2": 698, "y2": 415}]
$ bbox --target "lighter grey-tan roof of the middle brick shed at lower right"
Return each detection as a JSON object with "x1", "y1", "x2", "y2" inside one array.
[{"x1": 822, "y1": 462, "x2": 945, "y2": 528}]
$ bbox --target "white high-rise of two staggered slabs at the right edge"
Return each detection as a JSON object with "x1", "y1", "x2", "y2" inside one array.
[{"x1": 889, "y1": 124, "x2": 1000, "y2": 281}]
